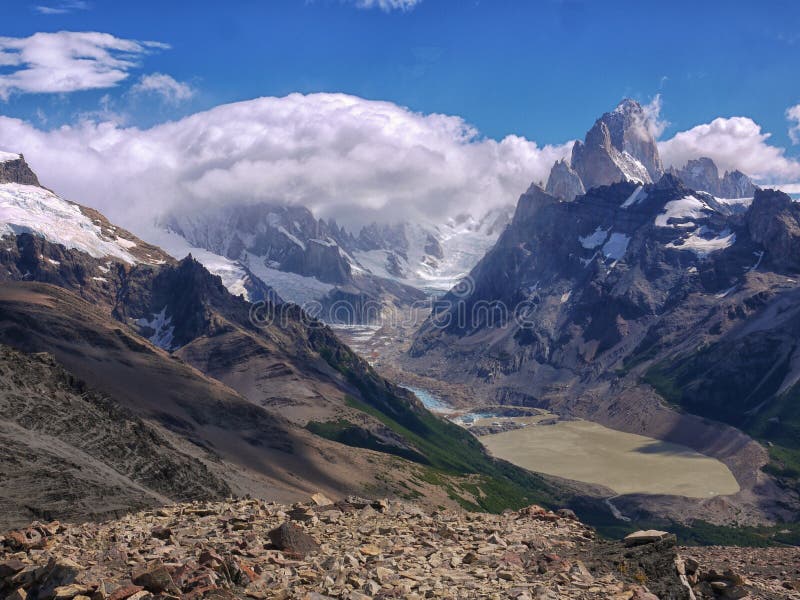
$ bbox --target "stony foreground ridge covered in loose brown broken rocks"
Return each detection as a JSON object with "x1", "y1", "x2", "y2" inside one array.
[{"x1": 0, "y1": 494, "x2": 800, "y2": 600}]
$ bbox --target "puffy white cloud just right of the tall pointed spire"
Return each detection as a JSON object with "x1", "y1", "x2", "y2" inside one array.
[{"x1": 658, "y1": 117, "x2": 800, "y2": 183}]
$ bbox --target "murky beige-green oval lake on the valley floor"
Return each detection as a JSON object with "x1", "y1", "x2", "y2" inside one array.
[{"x1": 479, "y1": 421, "x2": 739, "y2": 498}]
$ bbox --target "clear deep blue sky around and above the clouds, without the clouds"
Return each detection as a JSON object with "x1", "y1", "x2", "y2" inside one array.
[{"x1": 0, "y1": 0, "x2": 800, "y2": 146}]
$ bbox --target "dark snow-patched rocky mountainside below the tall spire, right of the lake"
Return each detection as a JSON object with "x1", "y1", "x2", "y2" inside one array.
[{"x1": 407, "y1": 111, "x2": 800, "y2": 522}]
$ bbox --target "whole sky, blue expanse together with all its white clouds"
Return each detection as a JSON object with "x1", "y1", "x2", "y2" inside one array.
[{"x1": 0, "y1": 0, "x2": 800, "y2": 230}]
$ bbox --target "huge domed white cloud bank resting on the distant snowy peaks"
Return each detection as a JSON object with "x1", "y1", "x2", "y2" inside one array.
[{"x1": 0, "y1": 94, "x2": 571, "y2": 228}]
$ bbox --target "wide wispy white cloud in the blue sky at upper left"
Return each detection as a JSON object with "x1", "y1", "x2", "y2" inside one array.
[{"x1": 0, "y1": 31, "x2": 169, "y2": 99}]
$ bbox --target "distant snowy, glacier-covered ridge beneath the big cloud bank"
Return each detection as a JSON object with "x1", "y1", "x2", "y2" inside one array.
[{"x1": 160, "y1": 203, "x2": 510, "y2": 322}]
